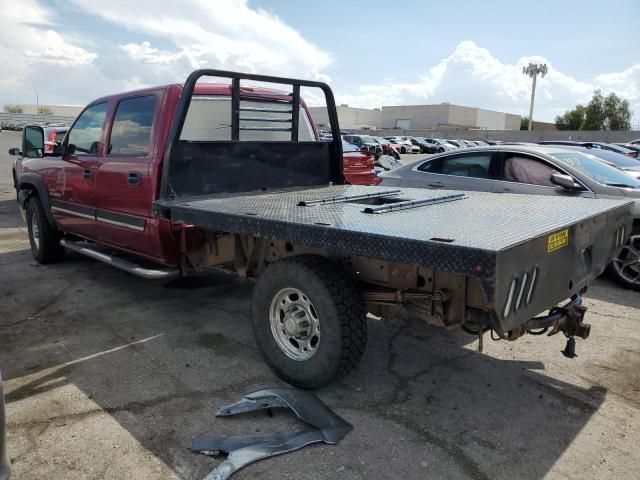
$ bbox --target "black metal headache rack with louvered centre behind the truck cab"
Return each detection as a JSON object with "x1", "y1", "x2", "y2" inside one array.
[{"x1": 155, "y1": 69, "x2": 344, "y2": 208}]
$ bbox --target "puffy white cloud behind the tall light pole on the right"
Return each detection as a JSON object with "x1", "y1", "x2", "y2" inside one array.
[{"x1": 337, "y1": 41, "x2": 640, "y2": 121}]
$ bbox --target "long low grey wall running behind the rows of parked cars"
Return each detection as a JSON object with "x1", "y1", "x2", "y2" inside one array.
[{"x1": 350, "y1": 128, "x2": 640, "y2": 143}]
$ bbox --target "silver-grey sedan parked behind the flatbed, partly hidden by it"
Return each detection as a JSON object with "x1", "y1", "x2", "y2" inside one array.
[{"x1": 379, "y1": 145, "x2": 640, "y2": 290}]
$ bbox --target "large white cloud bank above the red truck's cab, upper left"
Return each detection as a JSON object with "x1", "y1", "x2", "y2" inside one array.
[{"x1": 0, "y1": 0, "x2": 332, "y2": 104}]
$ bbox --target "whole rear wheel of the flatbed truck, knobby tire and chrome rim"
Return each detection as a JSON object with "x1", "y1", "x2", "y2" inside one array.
[{"x1": 251, "y1": 255, "x2": 367, "y2": 389}]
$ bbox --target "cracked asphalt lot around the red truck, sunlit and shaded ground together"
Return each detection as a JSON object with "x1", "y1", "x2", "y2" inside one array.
[{"x1": 0, "y1": 132, "x2": 640, "y2": 480}]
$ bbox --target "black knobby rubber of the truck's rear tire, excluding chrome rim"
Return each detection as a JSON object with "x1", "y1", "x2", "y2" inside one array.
[{"x1": 251, "y1": 255, "x2": 367, "y2": 389}]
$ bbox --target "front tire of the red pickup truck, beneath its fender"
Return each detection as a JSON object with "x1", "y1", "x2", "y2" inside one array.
[{"x1": 27, "y1": 197, "x2": 64, "y2": 264}]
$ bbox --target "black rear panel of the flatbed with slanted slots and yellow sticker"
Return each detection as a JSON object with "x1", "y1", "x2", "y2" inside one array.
[{"x1": 492, "y1": 204, "x2": 632, "y2": 333}]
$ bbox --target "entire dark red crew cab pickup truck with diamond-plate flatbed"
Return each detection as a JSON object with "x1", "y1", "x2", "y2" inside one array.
[{"x1": 14, "y1": 70, "x2": 631, "y2": 388}]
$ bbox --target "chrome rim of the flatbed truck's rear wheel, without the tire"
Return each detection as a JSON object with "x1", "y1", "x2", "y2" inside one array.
[{"x1": 269, "y1": 288, "x2": 320, "y2": 362}]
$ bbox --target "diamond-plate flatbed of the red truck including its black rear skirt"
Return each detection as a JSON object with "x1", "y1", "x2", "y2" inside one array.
[{"x1": 158, "y1": 185, "x2": 631, "y2": 331}]
